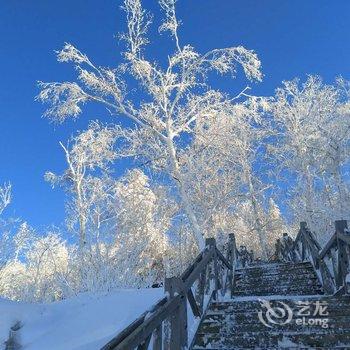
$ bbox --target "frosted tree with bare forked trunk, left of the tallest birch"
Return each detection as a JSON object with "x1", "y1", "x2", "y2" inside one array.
[{"x1": 45, "y1": 122, "x2": 117, "y2": 248}]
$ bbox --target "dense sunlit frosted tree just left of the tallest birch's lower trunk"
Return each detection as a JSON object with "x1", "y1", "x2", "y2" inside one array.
[{"x1": 116, "y1": 170, "x2": 172, "y2": 286}]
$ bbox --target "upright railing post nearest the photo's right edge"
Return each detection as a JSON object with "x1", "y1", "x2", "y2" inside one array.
[{"x1": 335, "y1": 220, "x2": 349, "y2": 288}]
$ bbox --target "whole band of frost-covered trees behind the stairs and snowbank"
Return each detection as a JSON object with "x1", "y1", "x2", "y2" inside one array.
[{"x1": 0, "y1": 0, "x2": 350, "y2": 300}]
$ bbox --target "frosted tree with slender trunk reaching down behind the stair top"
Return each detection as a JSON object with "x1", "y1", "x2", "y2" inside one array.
[{"x1": 183, "y1": 98, "x2": 271, "y2": 258}]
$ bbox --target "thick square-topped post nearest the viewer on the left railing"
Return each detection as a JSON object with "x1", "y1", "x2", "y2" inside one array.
[{"x1": 164, "y1": 277, "x2": 188, "y2": 350}]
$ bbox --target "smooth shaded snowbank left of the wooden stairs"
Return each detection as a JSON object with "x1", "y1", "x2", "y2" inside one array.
[{"x1": 0, "y1": 288, "x2": 164, "y2": 350}]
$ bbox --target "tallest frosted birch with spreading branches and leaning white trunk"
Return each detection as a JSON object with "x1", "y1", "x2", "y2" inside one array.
[{"x1": 38, "y1": 0, "x2": 262, "y2": 252}]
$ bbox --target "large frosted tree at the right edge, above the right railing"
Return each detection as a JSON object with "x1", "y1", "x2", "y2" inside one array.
[{"x1": 271, "y1": 76, "x2": 350, "y2": 233}]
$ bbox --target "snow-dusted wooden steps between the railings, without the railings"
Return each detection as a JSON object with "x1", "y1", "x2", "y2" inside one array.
[{"x1": 192, "y1": 262, "x2": 350, "y2": 350}]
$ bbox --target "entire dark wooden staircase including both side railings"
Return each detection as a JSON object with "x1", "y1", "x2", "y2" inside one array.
[{"x1": 102, "y1": 220, "x2": 350, "y2": 350}]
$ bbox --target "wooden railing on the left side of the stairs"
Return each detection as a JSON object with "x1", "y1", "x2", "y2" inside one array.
[{"x1": 101, "y1": 234, "x2": 237, "y2": 350}]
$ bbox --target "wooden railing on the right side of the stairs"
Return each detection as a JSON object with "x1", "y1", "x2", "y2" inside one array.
[{"x1": 276, "y1": 220, "x2": 350, "y2": 294}]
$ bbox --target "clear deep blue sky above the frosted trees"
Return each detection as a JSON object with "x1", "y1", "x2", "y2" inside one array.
[{"x1": 0, "y1": 0, "x2": 350, "y2": 227}]
